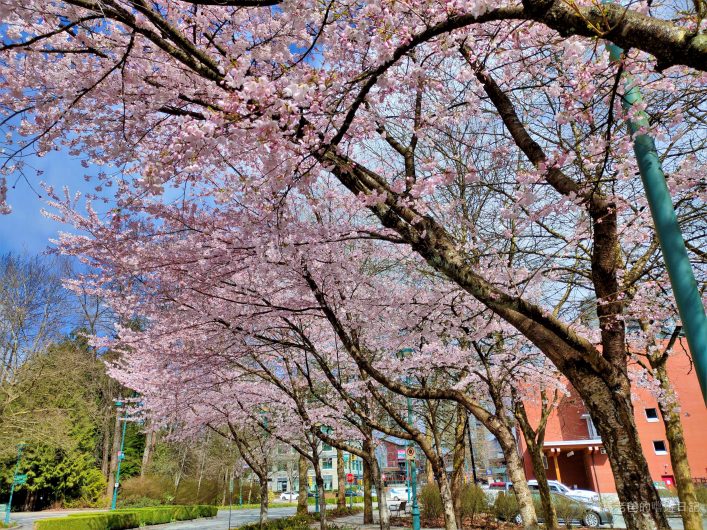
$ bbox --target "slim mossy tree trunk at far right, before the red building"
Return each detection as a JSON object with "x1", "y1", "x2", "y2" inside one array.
[{"x1": 655, "y1": 364, "x2": 702, "y2": 530}]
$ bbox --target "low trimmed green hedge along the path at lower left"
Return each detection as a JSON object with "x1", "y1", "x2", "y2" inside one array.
[{"x1": 34, "y1": 506, "x2": 218, "y2": 530}]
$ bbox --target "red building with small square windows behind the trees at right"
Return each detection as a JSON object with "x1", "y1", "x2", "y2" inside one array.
[{"x1": 521, "y1": 341, "x2": 707, "y2": 493}]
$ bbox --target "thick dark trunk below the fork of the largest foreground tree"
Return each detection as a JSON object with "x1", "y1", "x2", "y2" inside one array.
[{"x1": 571, "y1": 367, "x2": 670, "y2": 530}]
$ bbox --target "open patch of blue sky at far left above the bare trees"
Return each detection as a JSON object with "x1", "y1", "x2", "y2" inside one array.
[{"x1": 0, "y1": 151, "x2": 97, "y2": 254}]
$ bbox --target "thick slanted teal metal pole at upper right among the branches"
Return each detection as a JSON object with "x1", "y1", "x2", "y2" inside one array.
[{"x1": 607, "y1": 43, "x2": 707, "y2": 405}]
